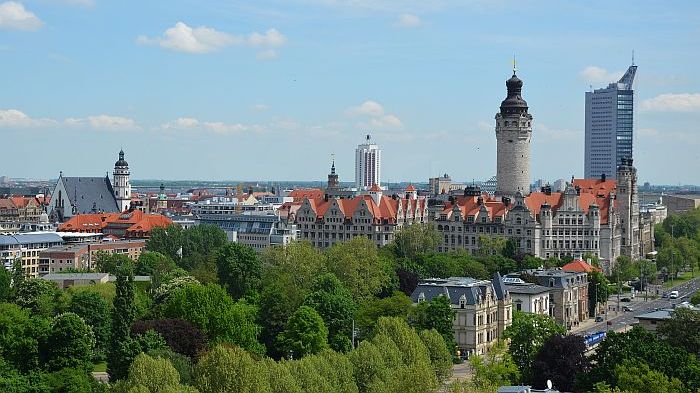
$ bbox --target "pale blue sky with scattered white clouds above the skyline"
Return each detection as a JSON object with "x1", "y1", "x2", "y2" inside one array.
[{"x1": 0, "y1": 0, "x2": 700, "y2": 184}]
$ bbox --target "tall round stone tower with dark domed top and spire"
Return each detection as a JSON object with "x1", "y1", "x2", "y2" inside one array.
[{"x1": 496, "y1": 66, "x2": 532, "y2": 197}]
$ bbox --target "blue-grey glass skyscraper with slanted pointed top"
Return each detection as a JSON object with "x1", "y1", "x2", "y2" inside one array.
[{"x1": 584, "y1": 63, "x2": 637, "y2": 179}]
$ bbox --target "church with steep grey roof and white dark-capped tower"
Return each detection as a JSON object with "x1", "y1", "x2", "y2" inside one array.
[{"x1": 48, "y1": 151, "x2": 131, "y2": 222}]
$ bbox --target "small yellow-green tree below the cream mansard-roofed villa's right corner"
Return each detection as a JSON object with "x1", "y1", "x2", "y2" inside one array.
[{"x1": 469, "y1": 341, "x2": 520, "y2": 388}]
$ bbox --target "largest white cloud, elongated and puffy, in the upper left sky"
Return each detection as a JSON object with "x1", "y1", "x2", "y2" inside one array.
[{"x1": 136, "y1": 22, "x2": 287, "y2": 54}]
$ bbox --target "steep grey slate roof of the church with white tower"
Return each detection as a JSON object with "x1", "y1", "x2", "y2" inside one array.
[{"x1": 61, "y1": 176, "x2": 119, "y2": 214}]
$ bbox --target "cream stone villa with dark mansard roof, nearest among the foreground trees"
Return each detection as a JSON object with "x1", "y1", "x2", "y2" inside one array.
[{"x1": 411, "y1": 273, "x2": 513, "y2": 356}]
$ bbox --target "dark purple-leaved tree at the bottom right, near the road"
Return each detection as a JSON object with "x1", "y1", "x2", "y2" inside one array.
[{"x1": 532, "y1": 334, "x2": 591, "y2": 392}]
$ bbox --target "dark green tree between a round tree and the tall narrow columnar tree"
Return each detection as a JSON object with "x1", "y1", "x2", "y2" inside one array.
[{"x1": 68, "y1": 291, "x2": 111, "y2": 359}]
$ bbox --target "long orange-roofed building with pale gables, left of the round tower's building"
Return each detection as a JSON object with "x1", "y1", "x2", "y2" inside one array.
[{"x1": 295, "y1": 184, "x2": 428, "y2": 248}]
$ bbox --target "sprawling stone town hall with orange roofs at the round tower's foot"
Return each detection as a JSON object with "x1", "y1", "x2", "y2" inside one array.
[{"x1": 431, "y1": 175, "x2": 620, "y2": 270}]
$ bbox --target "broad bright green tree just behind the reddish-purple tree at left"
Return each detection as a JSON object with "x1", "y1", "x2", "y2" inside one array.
[{"x1": 163, "y1": 284, "x2": 263, "y2": 353}]
